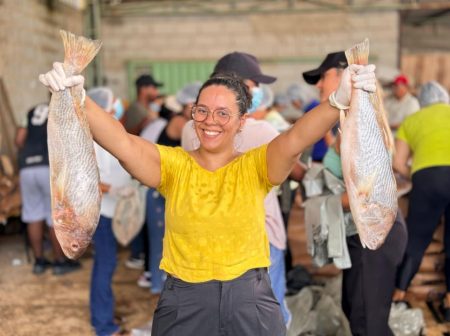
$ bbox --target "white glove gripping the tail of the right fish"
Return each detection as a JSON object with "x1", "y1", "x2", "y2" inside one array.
[{"x1": 334, "y1": 64, "x2": 377, "y2": 106}]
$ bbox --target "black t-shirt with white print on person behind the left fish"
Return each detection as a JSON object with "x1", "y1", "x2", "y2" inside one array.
[{"x1": 19, "y1": 104, "x2": 49, "y2": 169}]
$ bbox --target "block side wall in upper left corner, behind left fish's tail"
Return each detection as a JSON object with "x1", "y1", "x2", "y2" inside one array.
[{"x1": 0, "y1": 0, "x2": 83, "y2": 123}]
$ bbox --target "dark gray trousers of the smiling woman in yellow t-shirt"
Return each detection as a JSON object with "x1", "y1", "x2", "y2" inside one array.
[{"x1": 152, "y1": 268, "x2": 286, "y2": 336}]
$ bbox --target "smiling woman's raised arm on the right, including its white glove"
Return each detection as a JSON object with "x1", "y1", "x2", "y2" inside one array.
[{"x1": 267, "y1": 64, "x2": 376, "y2": 184}]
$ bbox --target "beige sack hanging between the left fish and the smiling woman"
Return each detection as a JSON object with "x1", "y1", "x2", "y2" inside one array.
[{"x1": 112, "y1": 181, "x2": 147, "y2": 246}]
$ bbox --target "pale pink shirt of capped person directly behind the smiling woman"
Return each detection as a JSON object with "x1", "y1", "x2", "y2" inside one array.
[{"x1": 181, "y1": 118, "x2": 286, "y2": 250}]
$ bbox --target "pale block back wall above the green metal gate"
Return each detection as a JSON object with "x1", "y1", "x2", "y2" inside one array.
[{"x1": 101, "y1": 11, "x2": 399, "y2": 97}]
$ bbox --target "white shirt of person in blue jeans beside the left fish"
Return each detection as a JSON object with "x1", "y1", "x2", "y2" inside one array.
[{"x1": 94, "y1": 143, "x2": 131, "y2": 218}]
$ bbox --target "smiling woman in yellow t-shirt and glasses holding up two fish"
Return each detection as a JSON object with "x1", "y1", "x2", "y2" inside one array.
[{"x1": 39, "y1": 53, "x2": 376, "y2": 336}]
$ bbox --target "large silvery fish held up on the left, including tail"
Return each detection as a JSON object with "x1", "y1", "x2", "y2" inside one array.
[{"x1": 47, "y1": 30, "x2": 101, "y2": 259}]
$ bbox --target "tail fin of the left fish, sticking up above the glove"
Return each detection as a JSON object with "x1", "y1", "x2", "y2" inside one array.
[{"x1": 59, "y1": 30, "x2": 102, "y2": 74}]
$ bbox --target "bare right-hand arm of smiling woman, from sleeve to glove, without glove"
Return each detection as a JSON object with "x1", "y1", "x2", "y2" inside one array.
[{"x1": 267, "y1": 102, "x2": 339, "y2": 185}]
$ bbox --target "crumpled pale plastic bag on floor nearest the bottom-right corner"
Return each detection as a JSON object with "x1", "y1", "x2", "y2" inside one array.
[{"x1": 389, "y1": 302, "x2": 425, "y2": 336}]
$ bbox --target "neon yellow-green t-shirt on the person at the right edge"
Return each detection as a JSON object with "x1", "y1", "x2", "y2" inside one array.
[{"x1": 396, "y1": 104, "x2": 450, "y2": 173}]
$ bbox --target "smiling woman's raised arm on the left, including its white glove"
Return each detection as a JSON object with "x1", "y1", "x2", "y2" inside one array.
[{"x1": 39, "y1": 63, "x2": 161, "y2": 187}]
